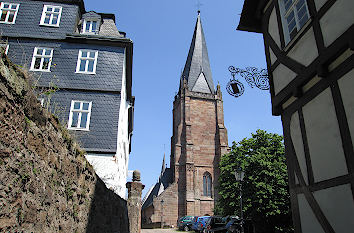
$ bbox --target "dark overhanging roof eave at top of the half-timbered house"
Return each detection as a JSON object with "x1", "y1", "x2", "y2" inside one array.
[{"x1": 237, "y1": 0, "x2": 269, "y2": 33}]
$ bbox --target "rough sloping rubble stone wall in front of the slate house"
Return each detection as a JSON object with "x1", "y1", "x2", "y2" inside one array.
[{"x1": 0, "y1": 54, "x2": 129, "y2": 233}]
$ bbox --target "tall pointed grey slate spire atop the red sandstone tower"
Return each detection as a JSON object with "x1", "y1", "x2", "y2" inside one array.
[{"x1": 182, "y1": 11, "x2": 215, "y2": 94}]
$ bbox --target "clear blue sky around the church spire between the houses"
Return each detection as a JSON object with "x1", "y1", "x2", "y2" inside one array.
[{"x1": 85, "y1": 0, "x2": 283, "y2": 196}]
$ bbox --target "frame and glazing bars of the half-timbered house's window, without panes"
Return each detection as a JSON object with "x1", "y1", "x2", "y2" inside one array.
[{"x1": 279, "y1": 0, "x2": 311, "y2": 45}]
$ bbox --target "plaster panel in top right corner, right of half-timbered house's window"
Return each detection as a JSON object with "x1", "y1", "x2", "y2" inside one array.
[{"x1": 320, "y1": 0, "x2": 354, "y2": 46}]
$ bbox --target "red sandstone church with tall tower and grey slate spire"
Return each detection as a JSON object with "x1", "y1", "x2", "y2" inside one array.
[{"x1": 142, "y1": 11, "x2": 229, "y2": 227}]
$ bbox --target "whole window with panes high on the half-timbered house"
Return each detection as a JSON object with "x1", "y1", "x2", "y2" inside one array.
[{"x1": 280, "y1": 0, "x2": 310, "y2": 44}]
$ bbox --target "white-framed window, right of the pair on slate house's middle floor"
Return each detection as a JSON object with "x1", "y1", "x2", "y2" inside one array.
[{"x1": 76, "y1": 50, "x2": 98, "y2": 74}]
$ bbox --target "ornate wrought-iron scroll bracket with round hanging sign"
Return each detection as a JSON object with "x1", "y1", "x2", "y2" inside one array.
[{"x1": 226, "y1": 66, "x2": 269, "y2": 97}]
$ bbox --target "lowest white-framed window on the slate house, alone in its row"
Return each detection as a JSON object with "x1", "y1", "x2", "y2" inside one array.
[{"x1": 68, "y1": 100, "x2": 92, "y2": 130}]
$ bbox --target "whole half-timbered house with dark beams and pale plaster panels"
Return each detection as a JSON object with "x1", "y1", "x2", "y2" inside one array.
[{"x1": 238, "y1": 0, "x2": 354, "y2": 233}]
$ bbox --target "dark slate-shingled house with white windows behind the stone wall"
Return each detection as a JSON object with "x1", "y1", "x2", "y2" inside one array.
[{"x1": 0, "y1": 0, "x2": 134, "y2": 198}]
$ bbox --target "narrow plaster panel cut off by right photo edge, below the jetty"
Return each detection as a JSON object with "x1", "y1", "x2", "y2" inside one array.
[{"x1": 338, "y1": 67, "x2": 354, "y2": 140}]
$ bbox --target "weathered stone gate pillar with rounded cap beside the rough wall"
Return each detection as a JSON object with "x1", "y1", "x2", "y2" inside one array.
[{"x1": 126, "y1": 170, "x2": 145, "y2": 233}]
